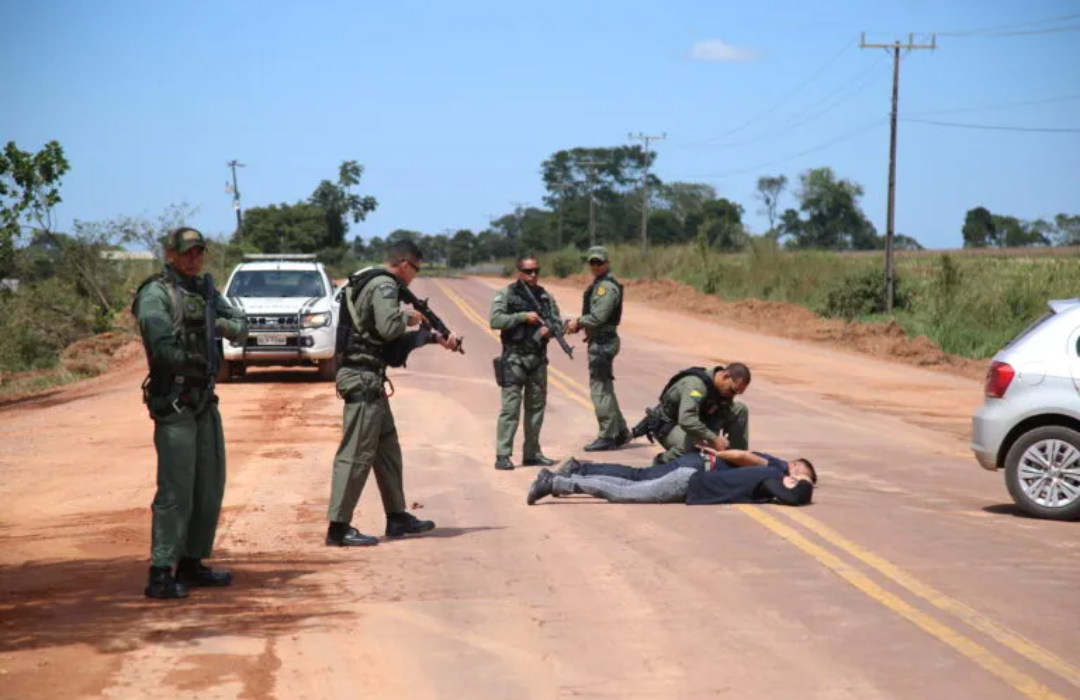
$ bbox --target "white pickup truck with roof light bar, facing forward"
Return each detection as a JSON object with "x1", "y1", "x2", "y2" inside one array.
[{"x1": 219, "y1": 254, "x2": 338, "y2": 381}]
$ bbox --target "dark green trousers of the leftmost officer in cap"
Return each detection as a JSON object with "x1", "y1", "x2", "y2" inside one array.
[{"x1": 150, "y1": 401, "x2": 225, "y2": 566}]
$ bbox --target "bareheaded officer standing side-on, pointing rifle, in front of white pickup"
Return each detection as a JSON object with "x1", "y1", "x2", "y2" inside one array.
[{"x1": 326, "y1": 241, "x2": 459, "y2": 547}]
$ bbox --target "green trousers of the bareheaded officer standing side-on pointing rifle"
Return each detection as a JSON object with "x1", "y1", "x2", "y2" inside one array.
[{"x1": 326, "y1": 367, "x2": 405, "y2": 523}]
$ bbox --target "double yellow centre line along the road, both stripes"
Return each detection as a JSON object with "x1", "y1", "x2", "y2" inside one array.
[{"x1": 435, "y1": 281, "x2": 1080, "y2": 700}]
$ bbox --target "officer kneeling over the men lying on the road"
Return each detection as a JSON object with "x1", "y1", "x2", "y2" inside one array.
[{"x1": 659, "y1": 362, "x2": 751, "y2": 462}]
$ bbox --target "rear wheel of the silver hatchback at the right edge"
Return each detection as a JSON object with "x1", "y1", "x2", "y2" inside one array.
[{"x1": 1005, "y1": 426, "x2": 1080, "y2": 520}]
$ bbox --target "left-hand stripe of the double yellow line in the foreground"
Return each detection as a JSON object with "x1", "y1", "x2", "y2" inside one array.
[{"x1": 735, "y1": 506, "x2": 1064, "y2": 700}]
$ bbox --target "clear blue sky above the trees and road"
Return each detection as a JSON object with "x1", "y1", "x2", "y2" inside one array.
[{"x1": 0, "y1": 0, "x2": 1080, "y2": 247}]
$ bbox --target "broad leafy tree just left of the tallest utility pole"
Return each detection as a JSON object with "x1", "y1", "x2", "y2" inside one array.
[{"x1": 780, "y1": 167, "x2": 882, "y2": 251}]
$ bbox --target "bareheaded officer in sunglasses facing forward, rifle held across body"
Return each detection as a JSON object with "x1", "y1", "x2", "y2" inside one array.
[{"x1": 490, "y1": 257, "x2": 563, "y2": 470}]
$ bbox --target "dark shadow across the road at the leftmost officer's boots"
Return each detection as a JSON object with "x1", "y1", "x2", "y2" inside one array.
[{"x1": 0, "y1": 555, "x2": 352, "y2": 654}]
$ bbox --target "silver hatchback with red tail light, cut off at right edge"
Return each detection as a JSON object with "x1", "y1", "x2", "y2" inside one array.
[{"x1": 971, "y1": 299, "x2": 1080, "y2": 520}]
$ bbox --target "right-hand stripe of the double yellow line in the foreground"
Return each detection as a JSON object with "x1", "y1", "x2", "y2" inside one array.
[{"x1": 783, "y1": 510, "x2": 1080, "y2": 687}]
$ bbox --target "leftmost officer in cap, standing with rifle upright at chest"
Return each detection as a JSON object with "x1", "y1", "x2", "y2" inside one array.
[{"x1": 132, "y1": 228, "x2": 247, "y2": 598}]
